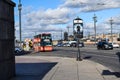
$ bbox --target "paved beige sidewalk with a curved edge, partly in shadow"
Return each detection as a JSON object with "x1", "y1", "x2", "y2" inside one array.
[{"x1": 12, "y1": 56, "x2": 120, "y2": 80}]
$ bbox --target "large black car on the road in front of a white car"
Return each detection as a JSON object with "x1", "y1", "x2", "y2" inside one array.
[{"x1": 97, "y1": 41, "x2": 113, "y2": 50}]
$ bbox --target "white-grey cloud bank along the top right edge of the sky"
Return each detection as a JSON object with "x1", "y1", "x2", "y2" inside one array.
[{"x1": 61, "y1": 0, "x2": 120, "y2": 12}]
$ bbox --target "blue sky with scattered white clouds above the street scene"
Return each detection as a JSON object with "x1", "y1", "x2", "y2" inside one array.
[{"x1": 13, "y1": 0, "x2": 120, "y2": 40}]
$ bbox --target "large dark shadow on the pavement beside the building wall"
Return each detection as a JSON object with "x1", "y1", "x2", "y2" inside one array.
[{"x1": 12, "y1": 62, "x2": 57, "y2": 80}]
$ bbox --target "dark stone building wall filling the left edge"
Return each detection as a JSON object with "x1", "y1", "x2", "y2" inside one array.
[{"x1": 0, "y1": 0, "x2": 15, "y2": 80}]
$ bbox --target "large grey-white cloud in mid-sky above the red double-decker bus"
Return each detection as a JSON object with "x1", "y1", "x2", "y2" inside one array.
[{"x1": 25, "y1": 8, "x2": 70, "y2": 26}]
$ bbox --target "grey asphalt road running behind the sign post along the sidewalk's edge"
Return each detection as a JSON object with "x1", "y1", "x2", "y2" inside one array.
[{"x1": 22, "y1": 45, "x2": 120, "y2": 72}]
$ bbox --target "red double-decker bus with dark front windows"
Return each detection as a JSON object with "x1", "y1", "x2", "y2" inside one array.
[{"x1": 33, "y1": 33, "x2": 53, "y2": 52}]
